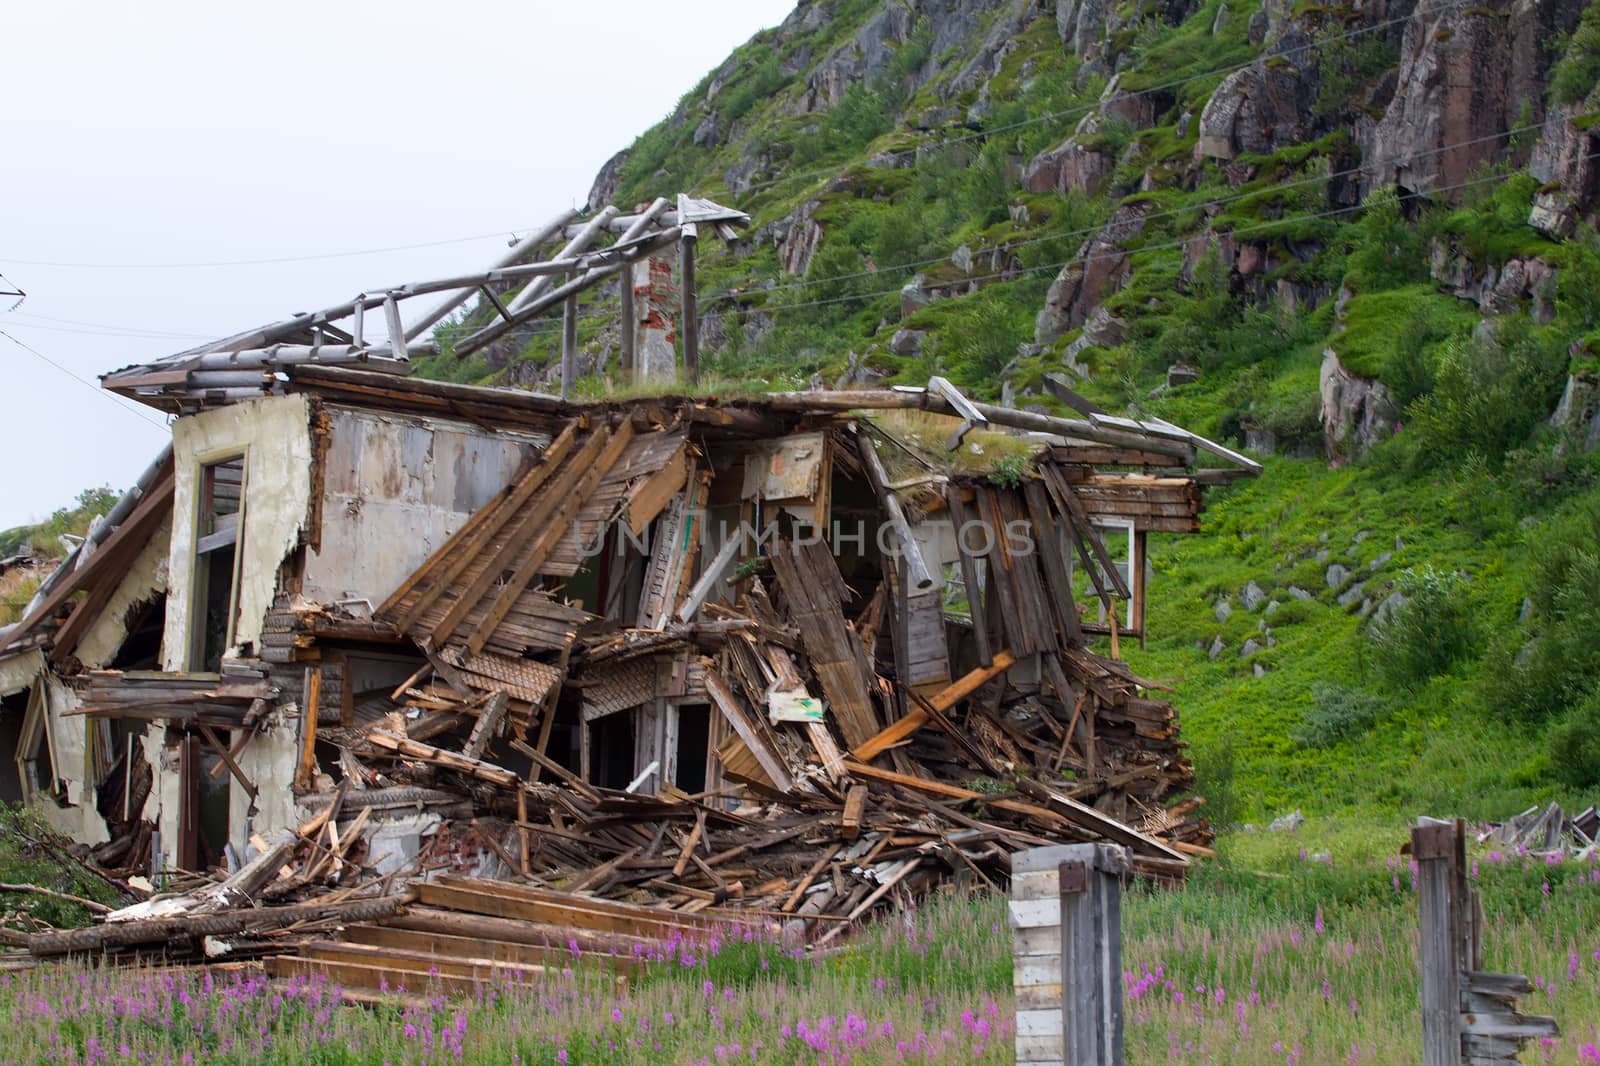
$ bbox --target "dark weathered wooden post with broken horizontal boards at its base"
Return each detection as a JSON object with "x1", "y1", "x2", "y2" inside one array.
[{"x1": 1411, "y1": 818, "x2": 1560, "y2": 1066}]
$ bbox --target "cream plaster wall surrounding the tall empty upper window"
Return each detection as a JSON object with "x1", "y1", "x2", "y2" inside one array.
[{"x1": 162, "y1": 395, "x2": 312, "y2": 671}]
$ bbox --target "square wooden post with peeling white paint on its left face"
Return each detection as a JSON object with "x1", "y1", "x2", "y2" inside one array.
[{"x1": 1010, "y1": 844, "x2": 1133, "y2": 1066}]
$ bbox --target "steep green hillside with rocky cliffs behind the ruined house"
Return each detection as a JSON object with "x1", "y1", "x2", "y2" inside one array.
[{"x1": 430, "y1": 0, "x2": 1600, "y2": 816}]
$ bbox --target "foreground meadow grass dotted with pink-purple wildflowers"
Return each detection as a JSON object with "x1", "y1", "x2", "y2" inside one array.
[{"x1": 0, "y1": 820, "x2": 1600, "y2": 1066}]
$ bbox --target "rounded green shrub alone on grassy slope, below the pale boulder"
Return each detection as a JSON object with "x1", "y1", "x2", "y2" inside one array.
[{"x1": 1371, "y1": 567, "x2": 1480, "y2": 688}]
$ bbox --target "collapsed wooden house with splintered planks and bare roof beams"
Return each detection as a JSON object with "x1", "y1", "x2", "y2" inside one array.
[{"x1": 0, "y1": 192, "x2": 1259, "y2": 972}]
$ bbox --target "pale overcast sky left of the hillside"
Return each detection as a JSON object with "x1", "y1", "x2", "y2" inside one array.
[{"x1": 0, "y1": 0, "x2": 794, "y2": 528}]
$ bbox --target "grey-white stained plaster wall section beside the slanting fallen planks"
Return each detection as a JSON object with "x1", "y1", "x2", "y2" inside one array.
[{"x1": 301, "y1": 405, "x2": 550, "y2": 607}]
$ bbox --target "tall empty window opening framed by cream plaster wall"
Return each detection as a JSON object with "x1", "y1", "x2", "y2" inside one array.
[{"x1": 189, "y1": 455, "x2": 245, "y2": 672}]
